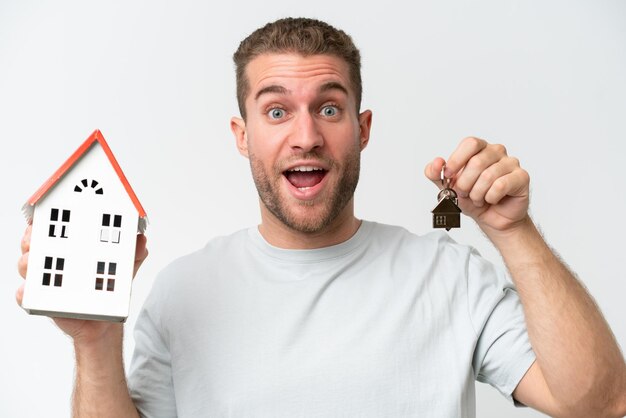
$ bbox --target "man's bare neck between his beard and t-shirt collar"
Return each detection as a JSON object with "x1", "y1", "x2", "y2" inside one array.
[{"x1": 259, "y1": 201, "x2": 361, "y2": 250}]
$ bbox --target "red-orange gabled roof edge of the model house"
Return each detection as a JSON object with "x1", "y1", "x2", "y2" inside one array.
[{"x1": 27, "y1": 129, "x2": 146, "y2": 218}]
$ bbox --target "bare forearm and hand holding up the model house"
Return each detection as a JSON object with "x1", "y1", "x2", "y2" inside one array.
[{"x1": 16, "y1": 226, "x2": 148, "y2": 418}]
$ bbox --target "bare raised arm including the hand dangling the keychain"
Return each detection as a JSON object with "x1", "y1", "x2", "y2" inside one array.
[{"x1": 425, "y1": 138, "x2": 626, "y2": 417}]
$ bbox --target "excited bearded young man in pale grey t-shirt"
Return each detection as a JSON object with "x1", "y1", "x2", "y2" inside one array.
[{"x1": 18, "y1": 19, "x2": 626, "y2": 417}]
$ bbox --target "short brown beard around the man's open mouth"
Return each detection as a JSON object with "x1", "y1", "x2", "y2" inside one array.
[{"x1": 249, "y1": 148, "x2": 361, "y2": 233}]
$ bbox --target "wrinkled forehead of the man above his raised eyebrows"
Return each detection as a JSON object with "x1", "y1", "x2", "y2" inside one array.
[{"x1": 246, "y1": 53, "x2": 350, "y2": 98}]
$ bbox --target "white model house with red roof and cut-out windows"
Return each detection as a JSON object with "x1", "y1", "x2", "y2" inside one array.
[{"x1": 22, "y1": 130, "x2": 147, "y2": 322}]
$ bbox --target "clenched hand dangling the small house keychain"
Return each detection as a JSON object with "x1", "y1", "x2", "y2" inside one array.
[{"x1": 424, "y1": 137, "x2": 530, "y2": 235}]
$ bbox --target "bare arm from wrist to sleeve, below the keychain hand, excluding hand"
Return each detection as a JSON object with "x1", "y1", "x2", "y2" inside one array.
[{"x1": 488, "y1": 218, "x2": 626, "y2": 417}]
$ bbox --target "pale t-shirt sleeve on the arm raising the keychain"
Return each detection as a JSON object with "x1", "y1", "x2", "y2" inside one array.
[{"x1": 467, "y1": 251, "x2": 535, "y2": 405}]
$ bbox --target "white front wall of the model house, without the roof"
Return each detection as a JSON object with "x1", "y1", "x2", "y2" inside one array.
[{"x1": 22, "y1": 142, "x2": 139, "y2": 321}]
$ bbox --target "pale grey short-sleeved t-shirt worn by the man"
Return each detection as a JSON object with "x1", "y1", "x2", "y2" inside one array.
[{"x1": 129, "y1": 221, "x2": 535, "y2": 418}]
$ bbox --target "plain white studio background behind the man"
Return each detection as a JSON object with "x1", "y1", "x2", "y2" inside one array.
[{"x1": 0, "y1": 0, "x2": 626, "y2": 417}]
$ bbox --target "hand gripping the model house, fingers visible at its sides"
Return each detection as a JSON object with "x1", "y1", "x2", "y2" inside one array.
[{"x1": 15, "y1": 225, "x2": 148, "y2": 344}]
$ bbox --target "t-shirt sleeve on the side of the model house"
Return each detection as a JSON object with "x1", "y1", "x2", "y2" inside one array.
[{"x1": 128, "y1": 280, "x2": 177, "y2": 418}]
